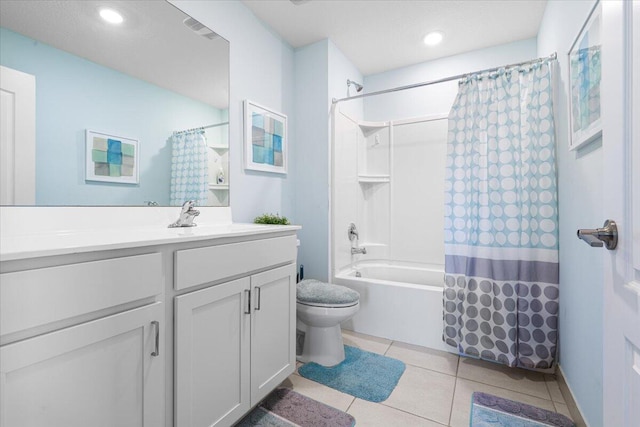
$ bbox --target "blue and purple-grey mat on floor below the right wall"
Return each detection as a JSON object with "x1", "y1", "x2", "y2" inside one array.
[{"x1": 470, "y1": 391, "x2": 574, "y2": 427}]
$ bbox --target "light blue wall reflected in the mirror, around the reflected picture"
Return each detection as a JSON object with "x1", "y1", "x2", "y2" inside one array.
[{"x1": 0, "y1": 28, "x2": 221, "y2": 206}]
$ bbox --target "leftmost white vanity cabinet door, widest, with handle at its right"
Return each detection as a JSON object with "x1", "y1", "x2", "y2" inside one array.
[{"x1": 0, "y1": 303, "x2": 164, "y2": 427}]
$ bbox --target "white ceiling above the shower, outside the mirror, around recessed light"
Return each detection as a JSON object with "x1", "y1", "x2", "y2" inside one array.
[{"x1": 243, "y1": 0, "x2": 547, "y2": 76}]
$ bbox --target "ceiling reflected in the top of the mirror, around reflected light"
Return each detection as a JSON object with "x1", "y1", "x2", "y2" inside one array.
[{"x1": 0, "y1": 0, "x2": 229, "y2": 109}]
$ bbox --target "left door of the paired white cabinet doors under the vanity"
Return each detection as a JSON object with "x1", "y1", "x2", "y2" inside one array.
[{"x1": 175, "y1": 277, "x2": 251, "y2": 427}]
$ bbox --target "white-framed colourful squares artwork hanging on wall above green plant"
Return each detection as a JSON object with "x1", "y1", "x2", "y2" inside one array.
[{"x1": 244, "y1": 100, "x2": 289, "y2": 174}]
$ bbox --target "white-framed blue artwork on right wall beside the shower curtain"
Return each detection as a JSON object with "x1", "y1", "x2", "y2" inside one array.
[{"x1": 568, "y1": 1, "x2": 602, "y2": 150}]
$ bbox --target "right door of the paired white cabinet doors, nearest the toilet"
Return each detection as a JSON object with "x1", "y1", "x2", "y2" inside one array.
[{"x1": 251, "y1": 264, "x2": 296, "y2": 405}]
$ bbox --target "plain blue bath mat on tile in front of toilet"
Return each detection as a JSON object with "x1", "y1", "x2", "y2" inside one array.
[{"x1": 298, "y1": 345, "x2": 405, "y2": 402}]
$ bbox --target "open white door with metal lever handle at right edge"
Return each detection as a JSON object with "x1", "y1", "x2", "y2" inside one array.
[{"x1": 601, "y1": 1, "x2": 640, "y2": 427}]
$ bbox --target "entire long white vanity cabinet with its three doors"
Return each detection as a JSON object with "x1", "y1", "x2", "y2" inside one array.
[{"x1": 0, "y1": 224, "x2": 299, "y2": 427}]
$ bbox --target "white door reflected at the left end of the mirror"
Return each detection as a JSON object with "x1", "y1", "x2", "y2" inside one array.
[{"x1": 0, "y1": 66, "x2": 36, "y2": 205}]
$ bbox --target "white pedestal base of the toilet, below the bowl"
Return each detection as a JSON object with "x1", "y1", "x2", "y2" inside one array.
[{"x1": 297, "y1": 324, "x2": 345, "y2": 366}]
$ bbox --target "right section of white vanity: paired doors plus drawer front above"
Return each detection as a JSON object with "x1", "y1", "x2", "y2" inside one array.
[{"x1": 174, "y1": 236, "x2": 296, "y2": 426}]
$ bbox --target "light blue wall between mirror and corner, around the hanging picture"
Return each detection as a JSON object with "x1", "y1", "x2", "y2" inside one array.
[{"x1": 171, "y1": 0, "x2": 299, "y2": 223}]
